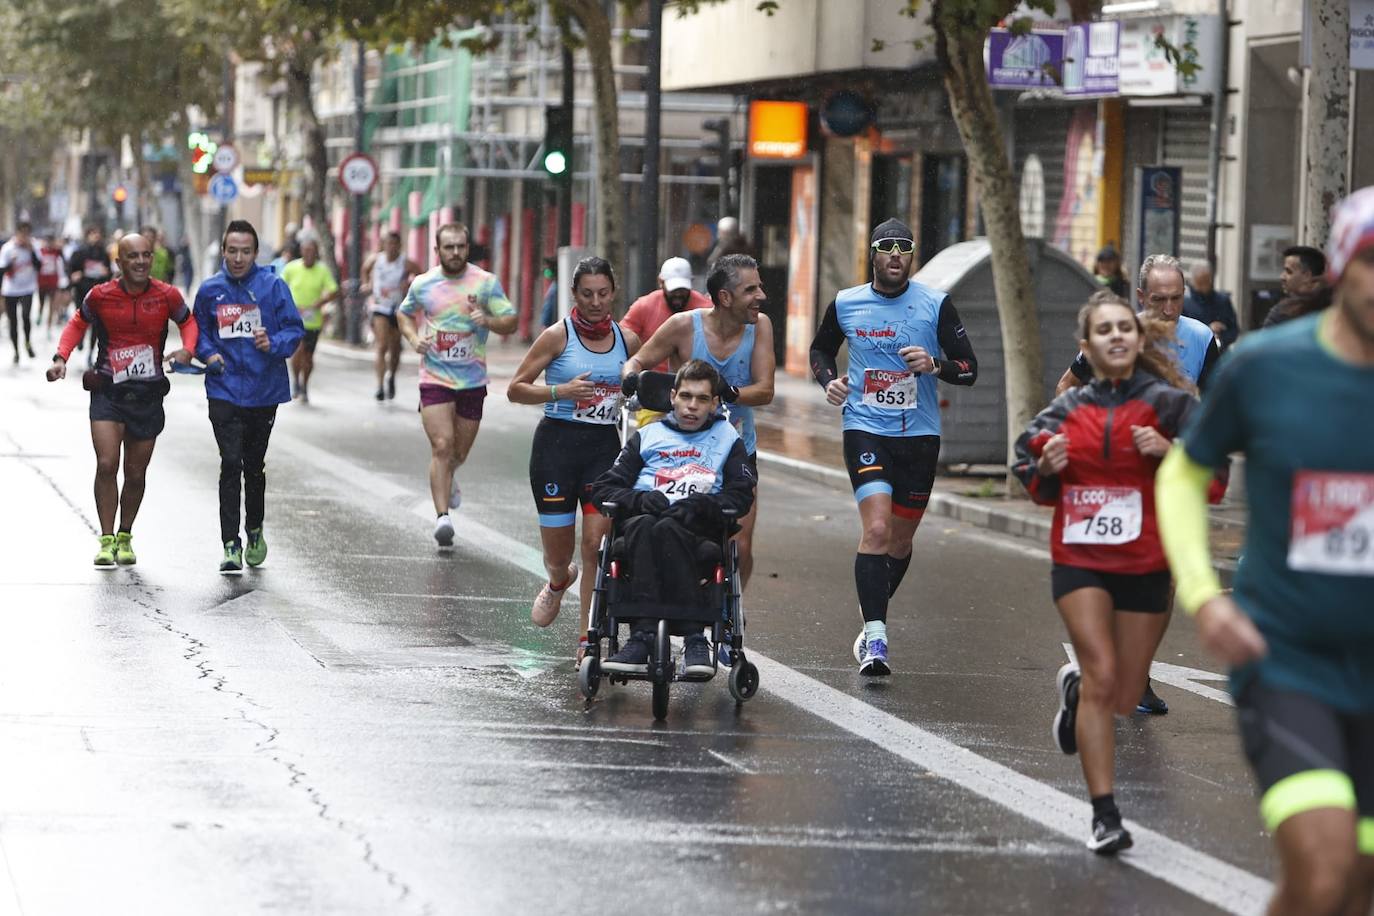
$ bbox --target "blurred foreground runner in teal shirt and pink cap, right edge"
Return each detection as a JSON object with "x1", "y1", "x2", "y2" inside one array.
[{"x1": 1158, "y1": 188, "x2": 1374, "y2": 915}]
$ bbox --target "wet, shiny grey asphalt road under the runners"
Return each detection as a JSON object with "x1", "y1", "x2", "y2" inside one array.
[{"x1": 0, "y1": 346, "x2": 1271, "y2": 915}]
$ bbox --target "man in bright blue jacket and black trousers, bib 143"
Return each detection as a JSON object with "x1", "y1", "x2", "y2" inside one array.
[{"x1": 195, "y1": 220, "x2": 305, "y2": 575}]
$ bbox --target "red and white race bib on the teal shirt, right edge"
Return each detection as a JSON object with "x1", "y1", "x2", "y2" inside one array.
[{"x1": 1289, "y1": 471, "x2": 1374, "y2": 575}]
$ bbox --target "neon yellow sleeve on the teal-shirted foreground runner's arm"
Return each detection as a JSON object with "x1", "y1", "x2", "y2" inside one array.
[{"x1": 1154, "y1": 442, "x2": 1221, "y2": 614}]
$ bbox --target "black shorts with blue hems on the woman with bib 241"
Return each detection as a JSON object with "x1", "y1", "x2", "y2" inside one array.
[{"x1": 529, "y1": 416, "x2": 620, "y2": 527}]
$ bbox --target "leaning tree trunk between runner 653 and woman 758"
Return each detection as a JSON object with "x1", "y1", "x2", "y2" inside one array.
[{"x1": 933, "y1": 12, "x2": 1044, "y2": 464}]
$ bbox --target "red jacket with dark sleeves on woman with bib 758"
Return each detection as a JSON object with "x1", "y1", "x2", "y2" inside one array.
[{"x1": 1011, "y1": 369, "x2": 1197, "y2": 574}]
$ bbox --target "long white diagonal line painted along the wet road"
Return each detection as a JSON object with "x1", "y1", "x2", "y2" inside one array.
[{"x1": 278, "y1": 437, "x2": 1274, "y2": 915}]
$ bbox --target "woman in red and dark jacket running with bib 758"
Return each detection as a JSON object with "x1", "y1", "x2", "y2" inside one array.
[{"x1": 1013, "y1": 291, "x2": 1195, "y2": 856}]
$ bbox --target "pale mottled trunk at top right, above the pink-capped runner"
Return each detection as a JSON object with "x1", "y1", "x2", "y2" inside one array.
[{"x1": 1303, "y1": 0, "x2": 1351, "y2": 247}]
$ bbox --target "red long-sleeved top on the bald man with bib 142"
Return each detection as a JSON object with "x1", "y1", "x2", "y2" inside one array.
[{"x1": 58, "y1": 280, "x2": 198, "y2": 382}]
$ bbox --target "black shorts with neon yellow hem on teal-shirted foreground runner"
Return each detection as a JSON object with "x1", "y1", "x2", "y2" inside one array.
[{"x1": 1235, "y1": 678, "x2": 1374, "y2": 856}]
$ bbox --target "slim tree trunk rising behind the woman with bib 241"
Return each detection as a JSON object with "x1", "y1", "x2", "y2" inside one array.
[{"x1": 569, "y1": 0, "x2": 629, "y2": 289}]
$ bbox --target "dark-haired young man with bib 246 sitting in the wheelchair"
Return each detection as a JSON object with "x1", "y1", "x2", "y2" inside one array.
[{"x1": 594, "y1": 360, "x2": 757, "y2": 677}]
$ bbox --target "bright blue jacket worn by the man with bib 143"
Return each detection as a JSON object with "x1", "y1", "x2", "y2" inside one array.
[{"x1": 194, "y1": 264, "x2": 305, "y2": 407}]
